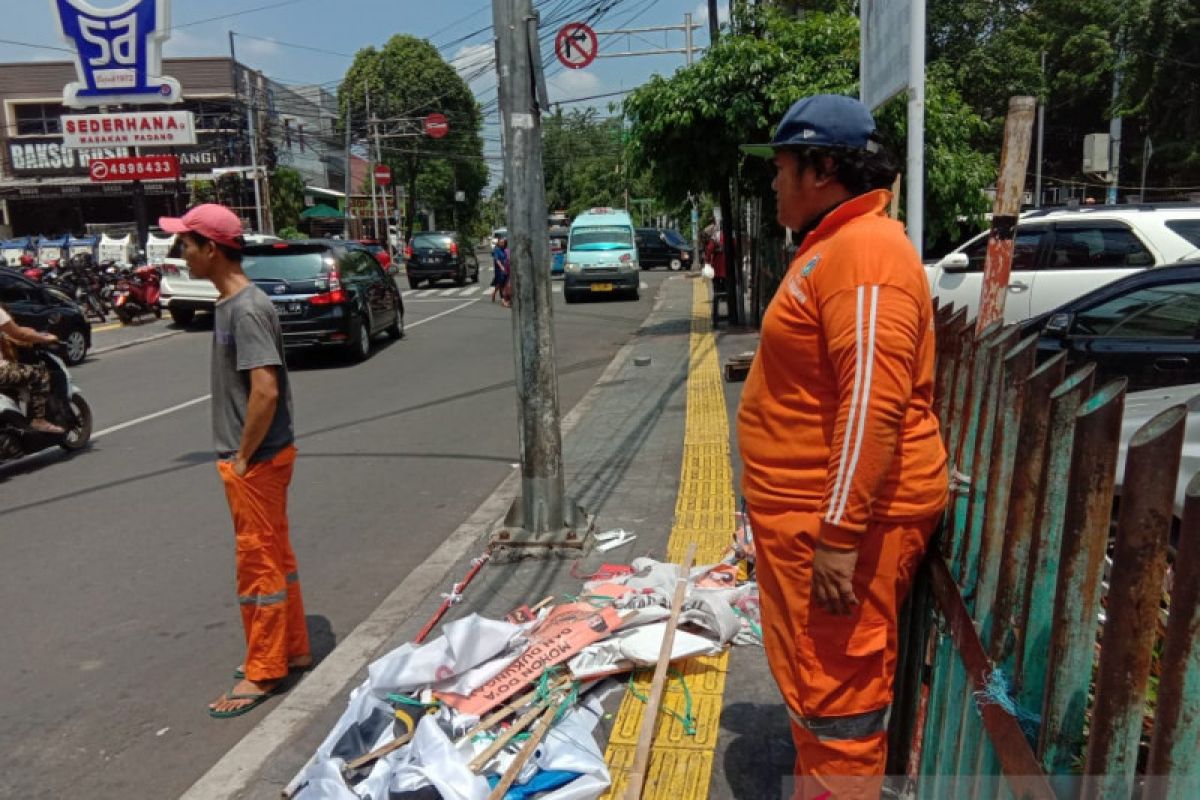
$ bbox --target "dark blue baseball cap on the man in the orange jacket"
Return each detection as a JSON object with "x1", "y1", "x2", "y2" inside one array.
[{"x1": 742, "y1": 95, "x2": 880, "y2": 158}]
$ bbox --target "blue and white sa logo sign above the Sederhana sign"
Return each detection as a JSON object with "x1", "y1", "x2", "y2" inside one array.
[{"x1": 50, "y1": 0, "x2": 181, "y2": 108}]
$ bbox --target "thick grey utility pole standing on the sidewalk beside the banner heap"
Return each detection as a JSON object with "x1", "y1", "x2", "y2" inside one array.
[{"x1": 492, "y1": 0, "x2": 589, "y2": 554}]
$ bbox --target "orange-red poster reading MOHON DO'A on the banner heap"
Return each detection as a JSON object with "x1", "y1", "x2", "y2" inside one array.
[{"x1": 439, "y1": 603, "x2": 620, "y2": 716}]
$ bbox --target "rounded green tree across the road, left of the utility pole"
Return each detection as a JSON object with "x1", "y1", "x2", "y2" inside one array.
[{"x1": 338, "y1": 35, "x2": 487, "y2": 236}]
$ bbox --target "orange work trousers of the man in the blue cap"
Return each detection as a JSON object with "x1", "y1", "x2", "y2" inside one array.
[{"x1": 750, "y1": 509, "x2": 936, "y2": 800}]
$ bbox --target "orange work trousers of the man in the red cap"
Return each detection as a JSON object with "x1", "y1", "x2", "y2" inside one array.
[{"x1": 217, "y1": 447, "x2": 308, "y2": 681}]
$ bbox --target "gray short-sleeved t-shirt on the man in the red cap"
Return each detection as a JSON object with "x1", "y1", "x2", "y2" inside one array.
[{"x1": 212, "y1": 284, "x2": 293, "y2": 463}]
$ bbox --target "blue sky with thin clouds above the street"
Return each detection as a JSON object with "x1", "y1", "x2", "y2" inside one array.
[{"x1": 0, "y1": 0, "x2": 728, "y2": 185}]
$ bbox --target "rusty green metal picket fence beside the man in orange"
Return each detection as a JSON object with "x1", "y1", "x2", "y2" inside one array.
[{"x1": 889, "y1": 307, "x2": 1200, "y2": 799}]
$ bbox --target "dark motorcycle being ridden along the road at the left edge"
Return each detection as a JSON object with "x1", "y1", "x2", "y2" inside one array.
[{"x1": 0, "y1": 347, "x2": 92, "y2": 463}]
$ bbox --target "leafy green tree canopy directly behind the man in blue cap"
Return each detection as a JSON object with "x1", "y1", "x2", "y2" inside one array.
[{"x1": 625, "y1": 4, "x2": 995, "y2": 250}]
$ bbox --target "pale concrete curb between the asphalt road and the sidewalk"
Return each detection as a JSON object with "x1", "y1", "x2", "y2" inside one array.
[{"x1": 181, "y1": 278, "x2": 681, "y2": 800}]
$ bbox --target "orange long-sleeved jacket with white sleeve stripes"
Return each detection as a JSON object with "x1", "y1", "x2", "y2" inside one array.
[{"x1": 738, "y1": 190, "x2": 947, "y2": 547}]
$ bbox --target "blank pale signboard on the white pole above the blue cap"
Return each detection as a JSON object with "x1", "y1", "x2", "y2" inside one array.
[{"x1": 859, "y1": 0, "x2": 911, "y2": 112}]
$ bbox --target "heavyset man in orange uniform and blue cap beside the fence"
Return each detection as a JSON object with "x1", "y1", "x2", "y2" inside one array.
[{"x1": 738, "y1": 95, "x2": 948, "y2": 799}]
